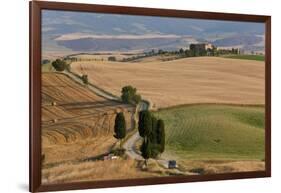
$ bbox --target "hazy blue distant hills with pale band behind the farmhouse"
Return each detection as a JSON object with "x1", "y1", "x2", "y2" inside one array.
[{"x1": 42, "y1": 10, "x2": 264, "y2": 53}]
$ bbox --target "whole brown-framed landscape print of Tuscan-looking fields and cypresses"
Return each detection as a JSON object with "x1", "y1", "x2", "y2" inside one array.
[{"x1": 30, "y1": 1, "x2": 271, "y2": 192}]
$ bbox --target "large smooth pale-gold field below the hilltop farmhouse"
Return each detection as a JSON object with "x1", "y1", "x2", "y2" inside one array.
[{"x1": 71, "y1": 57, "x2": 265, "y2": 108}]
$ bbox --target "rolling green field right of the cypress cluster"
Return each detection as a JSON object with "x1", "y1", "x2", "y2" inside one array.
[{"x1": 155, "y1": 104, "x2": 265, "y2": 160}]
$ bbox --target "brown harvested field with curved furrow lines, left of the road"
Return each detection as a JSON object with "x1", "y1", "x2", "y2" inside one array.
[{"x1": 41, "y1": 73, "x2": 134, "y2": 167}]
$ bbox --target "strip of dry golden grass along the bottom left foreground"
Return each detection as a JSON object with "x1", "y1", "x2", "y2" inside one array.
[{"x1": 42, "y1": 159, "x2": 161, "y2": 184}]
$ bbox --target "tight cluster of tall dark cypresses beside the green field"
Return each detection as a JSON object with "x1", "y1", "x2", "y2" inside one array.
[{"x1": 138, "y1": 110, "x2": 165, "y2": 165}]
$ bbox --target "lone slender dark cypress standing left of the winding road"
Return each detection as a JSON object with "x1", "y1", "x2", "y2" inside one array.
[{"x1": 114, "y1": 112, "x2": 126, "y2": 148}]
